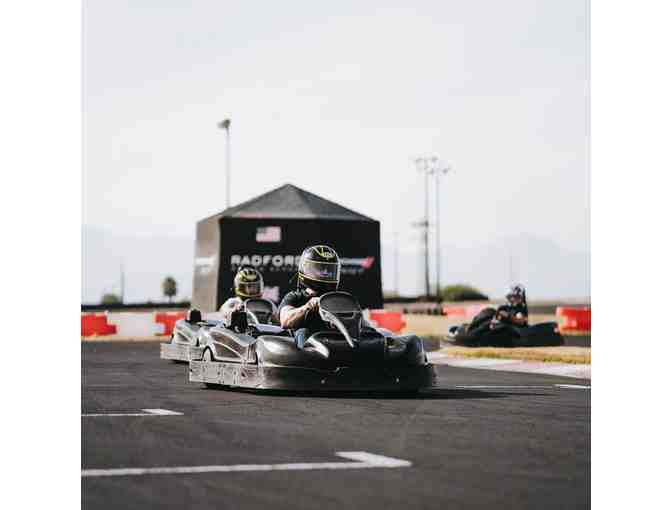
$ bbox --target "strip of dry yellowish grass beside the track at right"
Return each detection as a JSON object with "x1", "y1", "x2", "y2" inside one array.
[{"x1": 440, "y1": 346, "x2": 591, "y2": 365}]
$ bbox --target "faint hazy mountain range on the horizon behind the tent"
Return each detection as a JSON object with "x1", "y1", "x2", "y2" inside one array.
[{"x1": 81, "y1": 225, "x2": 590, "y2": 303}]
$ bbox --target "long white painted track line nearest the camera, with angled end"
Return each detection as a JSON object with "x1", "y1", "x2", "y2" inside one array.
[{"x1": 82, "y1": 452, "x2": 412, "y2": 478}]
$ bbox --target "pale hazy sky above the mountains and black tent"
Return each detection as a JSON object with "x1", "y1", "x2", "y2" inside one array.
[{"x1": 83, "y1": 0, "x2": 589, "y2": 266}]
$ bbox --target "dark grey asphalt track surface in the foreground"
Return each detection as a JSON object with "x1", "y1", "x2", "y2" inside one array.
[{"x1": 82, "y1": 342, "x2": 590, "y2": 510}]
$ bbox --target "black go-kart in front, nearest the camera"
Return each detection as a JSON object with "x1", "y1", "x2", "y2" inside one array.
[{"x1": 189, "y1": 292, "x2": 436, "y2": 391}]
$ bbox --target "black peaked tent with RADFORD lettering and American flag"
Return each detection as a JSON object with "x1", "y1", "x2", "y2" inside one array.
[{"x1": 192, "y1": 184, "x2": 383, "y2": 312}]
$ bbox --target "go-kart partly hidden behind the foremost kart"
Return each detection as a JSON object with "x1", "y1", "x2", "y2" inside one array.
[{"x1": 160, "y1": 298, "x2": 275, "y2": 362}]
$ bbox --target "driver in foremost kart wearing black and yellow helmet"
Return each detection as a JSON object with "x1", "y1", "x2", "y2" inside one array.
[{"x1": 278, "y1": 245, "x2": 341, "y2": 349}]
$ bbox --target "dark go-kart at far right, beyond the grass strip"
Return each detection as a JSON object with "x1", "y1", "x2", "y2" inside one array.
[{"x1": 448, "y1": 312, "x2": 565, "y2": 347}]
